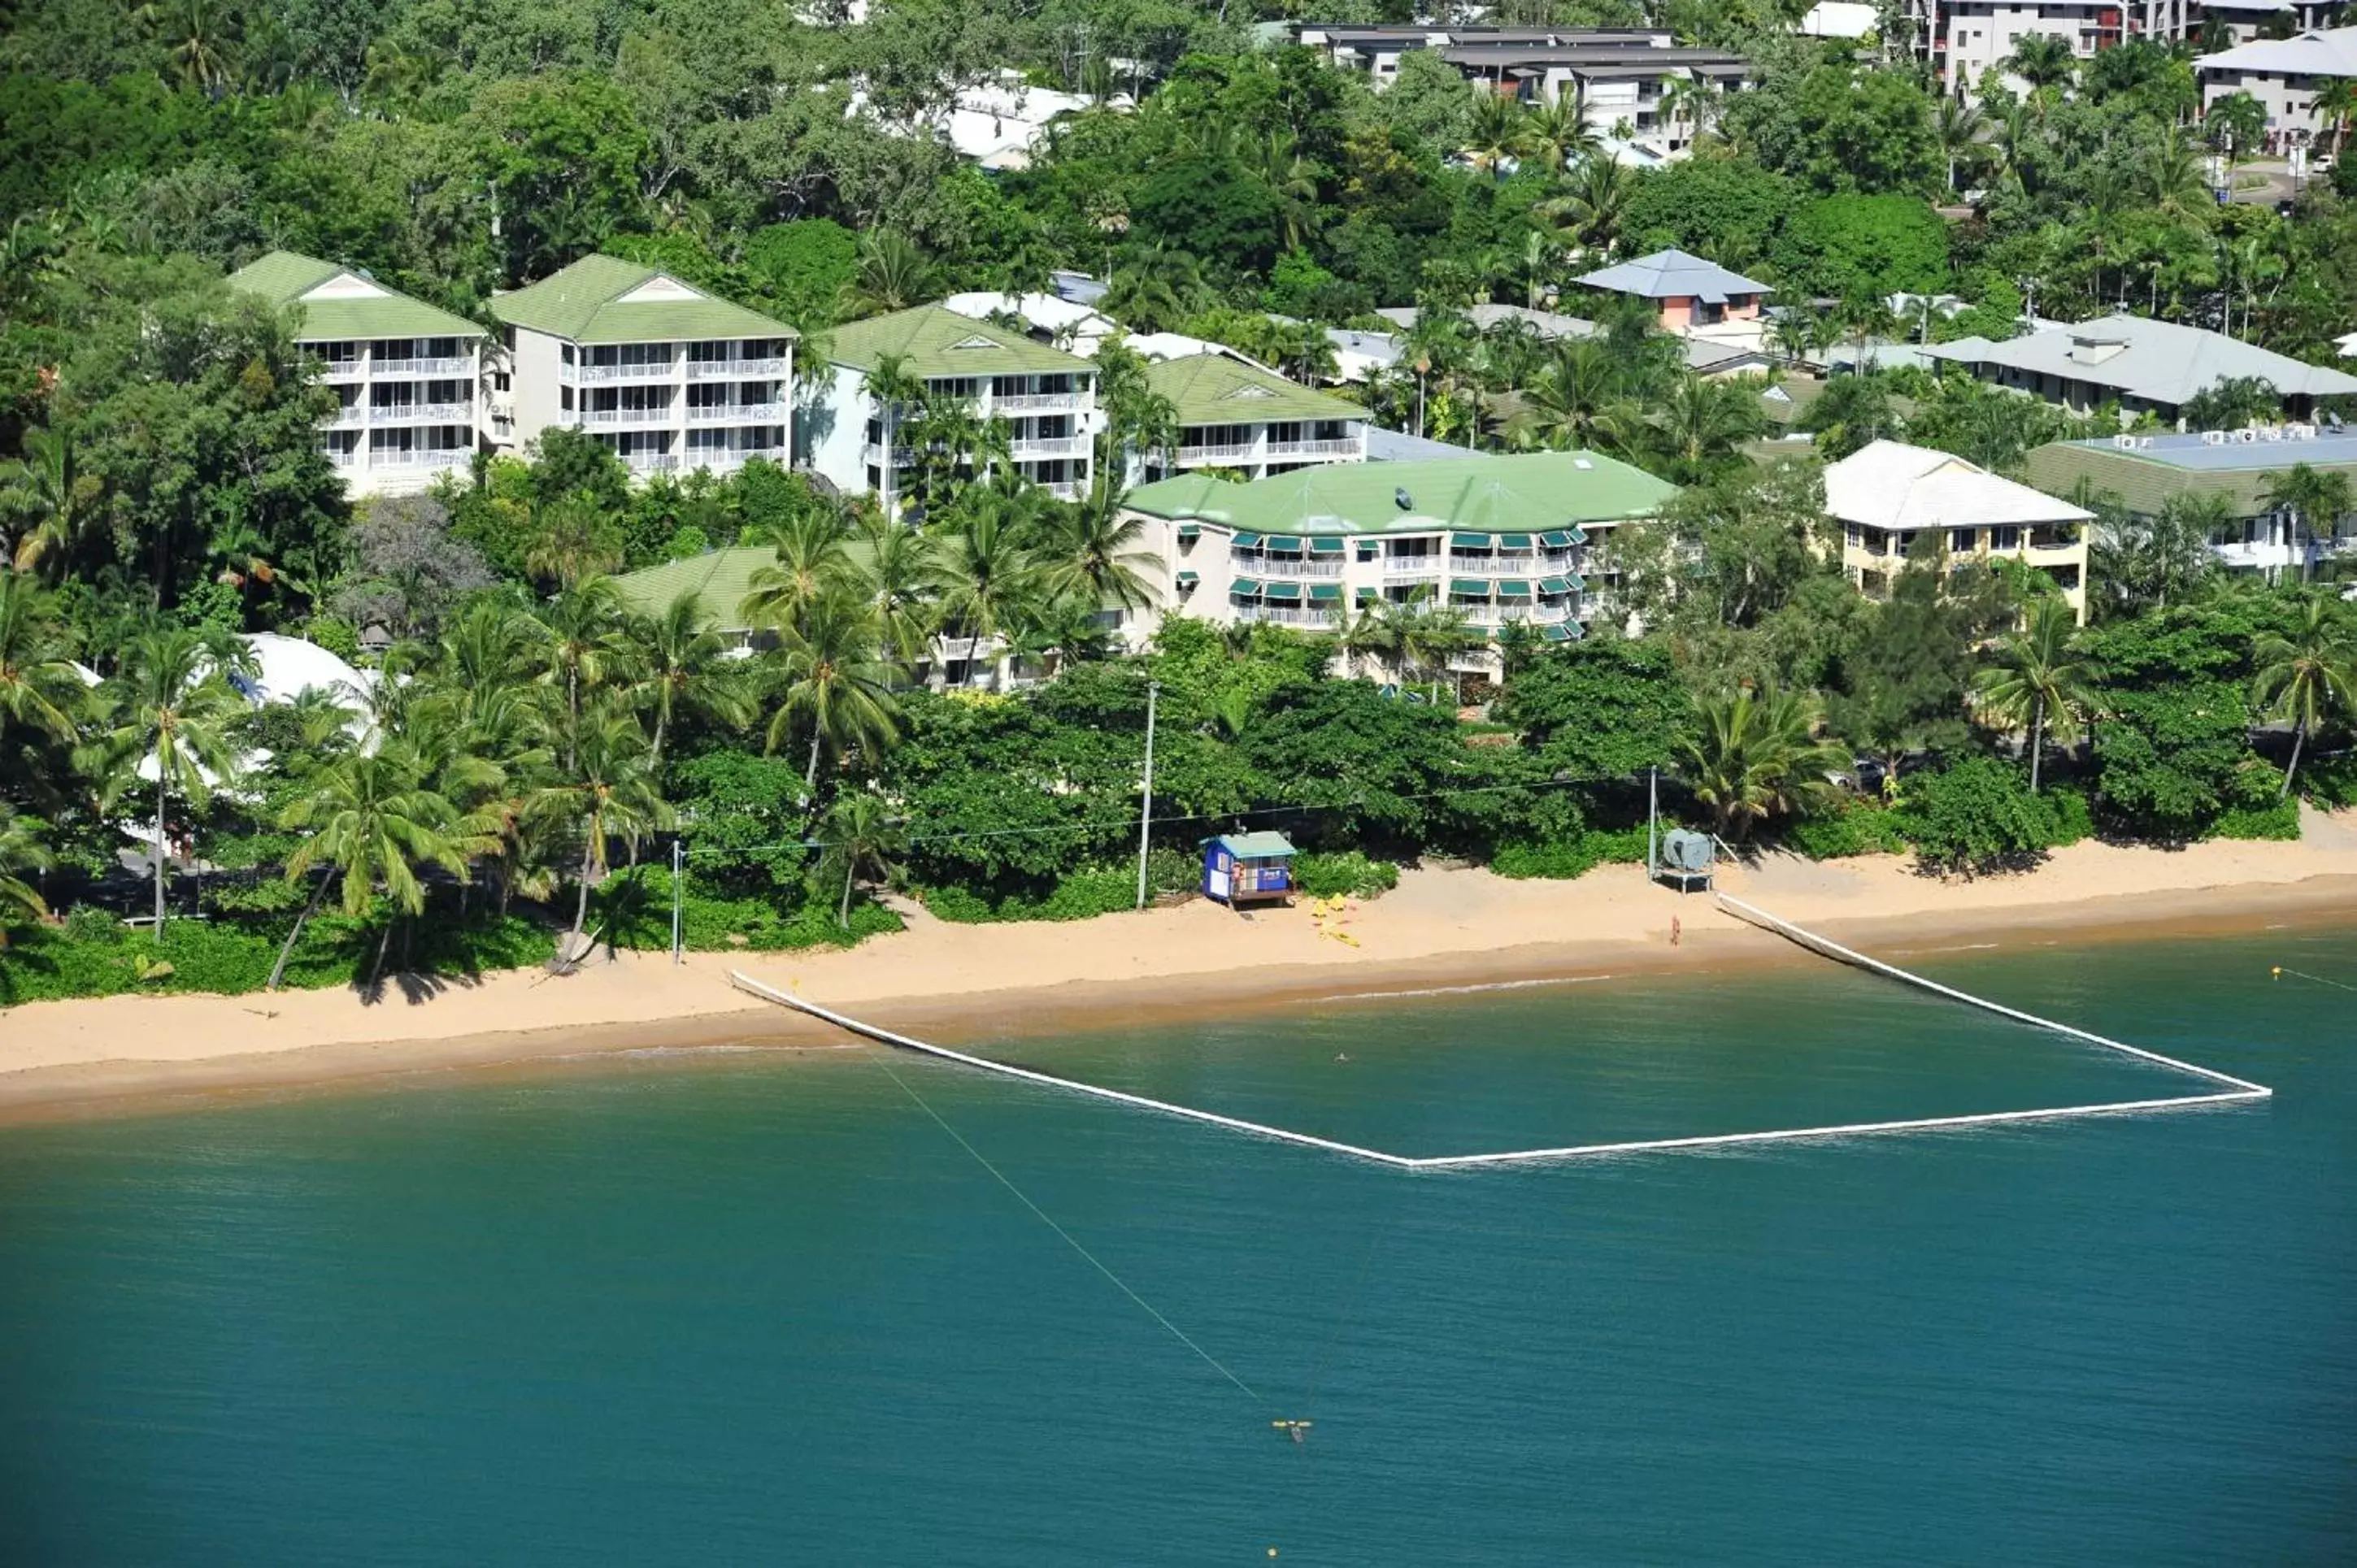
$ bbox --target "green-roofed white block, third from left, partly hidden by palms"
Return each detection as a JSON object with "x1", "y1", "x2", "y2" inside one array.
[{"x1": 799, "y1": 304, "x2": 1096, "y2": 497}]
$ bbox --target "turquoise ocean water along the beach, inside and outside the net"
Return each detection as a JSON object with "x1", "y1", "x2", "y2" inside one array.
[{"x1": 0, "y1": 932, "x2": 2357, "y2": 1566}]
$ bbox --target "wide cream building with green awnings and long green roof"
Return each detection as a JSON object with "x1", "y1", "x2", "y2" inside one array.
[{"x1": 1122, "y1": 453, "x2": 1678, "y2": 670}]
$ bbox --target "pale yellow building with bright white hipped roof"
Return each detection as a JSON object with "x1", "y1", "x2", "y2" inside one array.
[{"x1": 1824, "y1": 441, "x2": 2095, "y2": 625}]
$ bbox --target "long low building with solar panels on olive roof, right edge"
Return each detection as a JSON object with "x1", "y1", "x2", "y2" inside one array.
[{"x1": 2024, "y1": 424, "x2": 2357, "y2": 580}]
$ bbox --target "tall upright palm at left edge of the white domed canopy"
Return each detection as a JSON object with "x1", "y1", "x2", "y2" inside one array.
[{"x1": 102, "y1": 625, "x2": 252, "y2": 940}]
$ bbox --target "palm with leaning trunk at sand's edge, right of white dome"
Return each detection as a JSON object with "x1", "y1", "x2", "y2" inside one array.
[{"x1": 264, "y1": 741, "x2": 490, "y2": 990}]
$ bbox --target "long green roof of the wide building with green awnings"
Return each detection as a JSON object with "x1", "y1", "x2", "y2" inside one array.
[{"x1": 1127, "y1": 453, "x2": 1678, "y2": 533}]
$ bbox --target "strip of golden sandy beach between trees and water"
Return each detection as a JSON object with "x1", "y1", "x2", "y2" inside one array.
[{"x1": 0, "y1": 814, "x2": 2357, "y2": 1120}]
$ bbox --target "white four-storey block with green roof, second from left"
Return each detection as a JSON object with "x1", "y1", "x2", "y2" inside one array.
[{"x1": 490, "y1": 254, "x2": 794, "y2": 474}]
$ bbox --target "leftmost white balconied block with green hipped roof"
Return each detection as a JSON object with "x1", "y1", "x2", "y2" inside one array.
[{"x1": 228, "y1": 250, "x2": 485, "y2": 495}]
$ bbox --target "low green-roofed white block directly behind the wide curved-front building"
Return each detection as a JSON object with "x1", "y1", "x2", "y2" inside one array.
[{"x1": 1132, "y1": 351, "x2": 1367, "y2": 479}]
